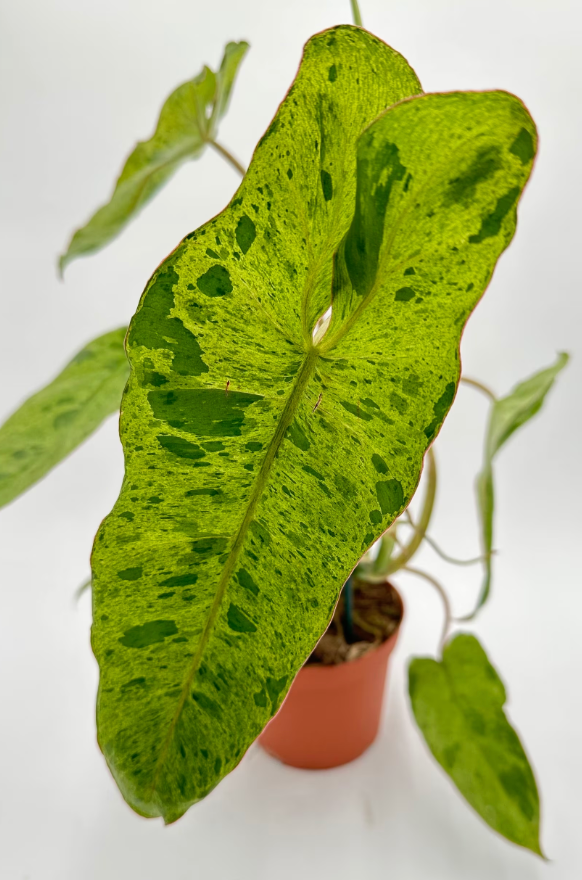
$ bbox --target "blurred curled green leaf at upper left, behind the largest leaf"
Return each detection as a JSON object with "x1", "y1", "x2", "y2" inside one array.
[{"x1": 59, "y1": 42, "x2": 248, "y2": 272}]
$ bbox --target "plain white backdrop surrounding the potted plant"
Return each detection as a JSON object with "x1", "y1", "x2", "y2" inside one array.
[{"x1": 0, "y1": 0, "x2": 582, "y2": 880}]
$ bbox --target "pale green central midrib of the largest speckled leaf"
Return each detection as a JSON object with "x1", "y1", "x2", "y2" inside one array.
[{"x1": 150, "y1": 346, "x2": 320, "y2": 795}]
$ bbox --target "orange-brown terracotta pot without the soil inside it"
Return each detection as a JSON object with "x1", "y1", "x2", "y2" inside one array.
[{"x1": 259, "y1": 597, "x2": 402, "y2": 770}]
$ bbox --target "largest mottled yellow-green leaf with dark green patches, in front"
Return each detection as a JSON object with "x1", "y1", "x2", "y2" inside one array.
[{"x1": 93, "y1": 26, "x2": 535, "y2": 821}]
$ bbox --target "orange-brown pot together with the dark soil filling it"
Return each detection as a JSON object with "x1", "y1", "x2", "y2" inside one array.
[{"x1": 259, "y1": 582, "x2": 403, "y2": 769}]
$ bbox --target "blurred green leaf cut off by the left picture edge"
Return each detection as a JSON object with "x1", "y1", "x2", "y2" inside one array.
[{"x1": 0, "y1": 327, "x2": 129, "y2": 507}]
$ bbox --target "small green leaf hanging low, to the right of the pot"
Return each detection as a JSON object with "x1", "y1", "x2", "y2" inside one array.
[{"x1": 409, "y1": 634, "x2": 542, "y2": 855}]
